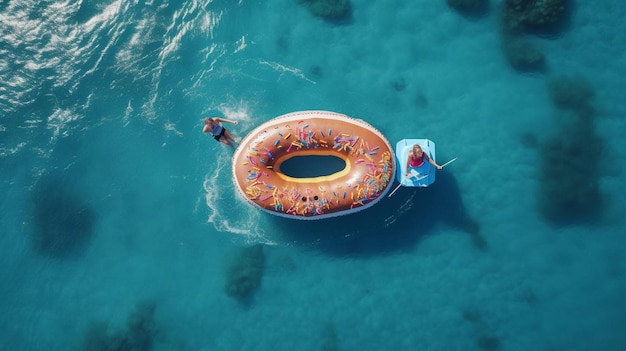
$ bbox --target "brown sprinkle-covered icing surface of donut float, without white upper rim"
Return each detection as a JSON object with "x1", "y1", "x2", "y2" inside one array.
[{"x1": 233, "y1": 111, "x2": 395, "y2": 217}]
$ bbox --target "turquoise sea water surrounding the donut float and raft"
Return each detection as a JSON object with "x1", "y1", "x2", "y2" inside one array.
[{"x1": 0, "y1": 0, "x2": 626, "y2": 350}]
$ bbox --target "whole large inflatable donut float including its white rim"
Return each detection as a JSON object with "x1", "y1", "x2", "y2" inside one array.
[{"x1": 233, "y1": 111, "x2": 396, "y2": 219}]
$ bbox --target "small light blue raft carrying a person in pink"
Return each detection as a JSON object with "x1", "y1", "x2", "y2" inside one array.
[{"x1": 396, "y1": 139, "x2": 437, "y2": 188}]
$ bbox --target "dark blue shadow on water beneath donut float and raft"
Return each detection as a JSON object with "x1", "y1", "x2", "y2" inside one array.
[{"x1": 272, "y1": 170, "x2": 487, "y2": 256}]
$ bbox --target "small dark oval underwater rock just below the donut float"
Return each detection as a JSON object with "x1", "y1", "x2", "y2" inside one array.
[{"x1": 224, "y1": 244, "x2": 265, "y2": 299}]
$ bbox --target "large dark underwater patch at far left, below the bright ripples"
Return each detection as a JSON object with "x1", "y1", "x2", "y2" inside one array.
[{"x1": 31, "y1": 175, "x2": 96, "y2": 258}]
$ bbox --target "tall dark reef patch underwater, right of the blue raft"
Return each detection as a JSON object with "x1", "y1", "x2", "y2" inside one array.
[{"x1": 538, "y1": 76, "x2": 606, "y2": 224}]
